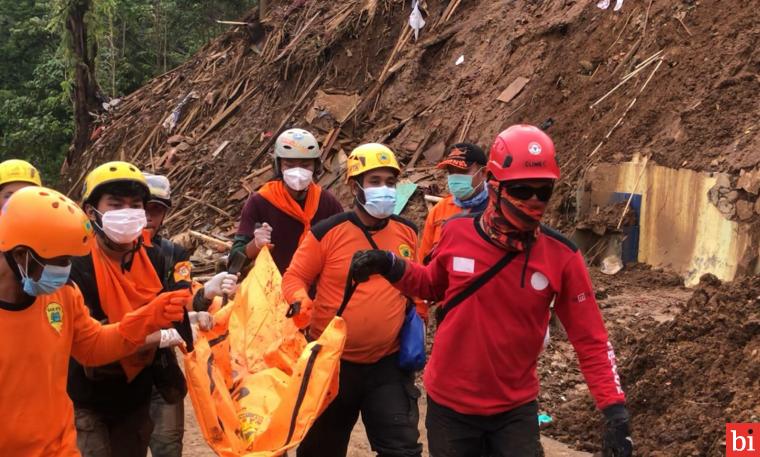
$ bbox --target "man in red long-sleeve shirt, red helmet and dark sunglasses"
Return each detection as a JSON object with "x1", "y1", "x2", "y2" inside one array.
[{"x1": 352, "y1": 125, "x2": 632, "y2": 457}]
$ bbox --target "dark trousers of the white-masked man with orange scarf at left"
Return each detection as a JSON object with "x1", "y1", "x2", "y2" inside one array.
[{"x1": 74, "y1": 403, "x2": 153, "y2": 457}]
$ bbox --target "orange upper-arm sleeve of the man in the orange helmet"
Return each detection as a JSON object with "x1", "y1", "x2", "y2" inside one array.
[{"x1": 71, "y1": 293, "x2": 138, "y2": 366}]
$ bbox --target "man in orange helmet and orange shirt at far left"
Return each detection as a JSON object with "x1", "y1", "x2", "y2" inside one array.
[{"x1": 0, "y1": 186, "x2": 190, "y2": 457}]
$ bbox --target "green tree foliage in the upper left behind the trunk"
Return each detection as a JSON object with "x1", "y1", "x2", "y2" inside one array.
[{"x1": 0, "y1": 0, "x2": 256, "y2": 183}]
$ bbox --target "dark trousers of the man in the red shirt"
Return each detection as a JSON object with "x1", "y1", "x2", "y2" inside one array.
[{"x1": 425, "y1": 396, "x2": 543, "y2": 457}]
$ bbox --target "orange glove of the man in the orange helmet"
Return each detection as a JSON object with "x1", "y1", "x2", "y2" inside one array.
[{"x1": 119, "y1": 289, "x2": 192, "y2": 345}]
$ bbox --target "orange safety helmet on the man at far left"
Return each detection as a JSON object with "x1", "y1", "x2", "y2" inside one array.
[{"x1": 0, "y1": 186, "x2": 93, "y2": 259}]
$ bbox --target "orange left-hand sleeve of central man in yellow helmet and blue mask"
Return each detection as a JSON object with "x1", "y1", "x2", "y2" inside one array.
[{"x1": 282, "y1": 232, "x2": 325, "y2": 320}]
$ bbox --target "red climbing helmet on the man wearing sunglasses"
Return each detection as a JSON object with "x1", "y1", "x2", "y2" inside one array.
[{"x1": 487, "y1": 125, "x2": 559, "y2": 181}]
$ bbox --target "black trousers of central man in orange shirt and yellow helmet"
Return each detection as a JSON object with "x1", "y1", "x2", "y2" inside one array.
[{"x1": 297, "y1": 354, "x2": 422, "y2": 457}]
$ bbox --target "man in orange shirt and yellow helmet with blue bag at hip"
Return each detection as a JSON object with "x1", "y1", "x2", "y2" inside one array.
[{"x1": 282, "y1": 143, "x2": 422, "y2": 457}]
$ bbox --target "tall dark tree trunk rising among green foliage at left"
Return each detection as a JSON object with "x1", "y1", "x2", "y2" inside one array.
[{"x1": 66, "y1": 0, "x2": 101, "y2": 164}]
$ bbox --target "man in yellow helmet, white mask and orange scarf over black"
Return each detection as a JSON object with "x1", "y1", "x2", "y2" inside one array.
[{"x1": 68, "y1": 162, "x2": 197, "y2": 457}]
